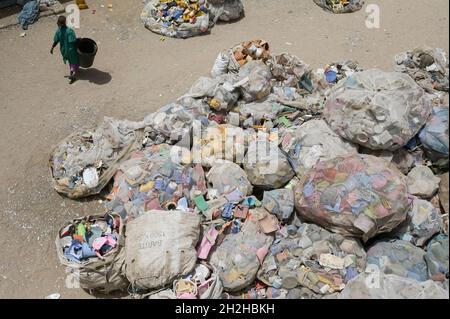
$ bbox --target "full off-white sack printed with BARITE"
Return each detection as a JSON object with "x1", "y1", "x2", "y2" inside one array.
[{"x1": 125, "y1": 210, "x2": 200, "y2": 290}]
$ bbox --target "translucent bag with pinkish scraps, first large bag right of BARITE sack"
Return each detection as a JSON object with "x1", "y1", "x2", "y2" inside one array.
[{"x1": 210, "y1": 219, "x2": 273, "y2": 291}]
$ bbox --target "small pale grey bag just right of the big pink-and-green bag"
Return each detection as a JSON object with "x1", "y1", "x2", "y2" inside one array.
[{"x1": 406, "y1": 165, "x2": 441, "y2": 198}]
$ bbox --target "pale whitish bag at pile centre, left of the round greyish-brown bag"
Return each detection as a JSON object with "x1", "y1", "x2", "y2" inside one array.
[{"x1": 206, "y1": 162, "x2": 253, "y2": 196}]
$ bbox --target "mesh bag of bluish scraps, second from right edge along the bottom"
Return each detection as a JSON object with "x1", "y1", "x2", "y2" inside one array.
[{"x1": 367, "y1": 240, "x2": 428, "y2": 281}]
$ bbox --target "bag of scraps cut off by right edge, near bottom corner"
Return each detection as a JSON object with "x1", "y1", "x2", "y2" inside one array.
[{"x1": 425, "y1": 234, "x2": 449, "y2": 281}]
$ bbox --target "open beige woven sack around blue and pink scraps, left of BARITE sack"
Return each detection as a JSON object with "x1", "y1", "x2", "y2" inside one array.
[{"x1": 55, "y1": 214, "x2": 129, "y2": 294}]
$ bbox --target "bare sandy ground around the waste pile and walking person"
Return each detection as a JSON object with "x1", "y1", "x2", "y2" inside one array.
[{"x1": 0, "y1": 0, "x2": 449, "y2": 298}]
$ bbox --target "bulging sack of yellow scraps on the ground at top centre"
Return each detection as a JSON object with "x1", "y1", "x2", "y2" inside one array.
[{"x1": 141, "y1": 0, "x2": 212, "y2": 39}]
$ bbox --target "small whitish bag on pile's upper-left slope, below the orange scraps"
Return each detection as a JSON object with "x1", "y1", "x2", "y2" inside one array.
[{"x1": 183, "y1": 74, "x2": 240, "y2": 112}]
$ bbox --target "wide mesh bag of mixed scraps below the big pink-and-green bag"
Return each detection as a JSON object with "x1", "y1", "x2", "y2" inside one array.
[{"x1": 258, "y1": 224, "x2": 366, "y2": 295}]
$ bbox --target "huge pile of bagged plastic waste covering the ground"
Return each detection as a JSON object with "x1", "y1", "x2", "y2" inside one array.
[{"x1": 50, "y1": 40, "x2": 449, "y2": 299}]
